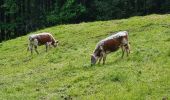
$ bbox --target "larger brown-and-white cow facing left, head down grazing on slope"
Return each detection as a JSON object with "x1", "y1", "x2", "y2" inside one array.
[{"x1": 91, "y1": 31, "x2": 130, "y2": 65}]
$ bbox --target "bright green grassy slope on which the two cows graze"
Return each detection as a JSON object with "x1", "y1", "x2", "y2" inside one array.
[{"x1": 0, "y1": 15, "x2": 170, "y2": 100}]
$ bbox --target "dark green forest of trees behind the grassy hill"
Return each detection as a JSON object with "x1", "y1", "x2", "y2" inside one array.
[{"x1": 0, "y1": 0, "x2": 170, "y2": 42}]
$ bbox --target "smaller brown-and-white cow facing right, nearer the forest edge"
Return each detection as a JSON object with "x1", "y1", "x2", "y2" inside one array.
[{"x1": 28, "y1": 33, "x2": 58, "y2": 54}]
